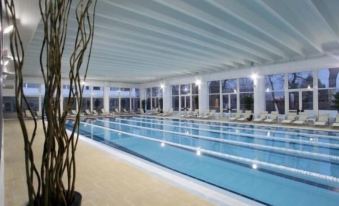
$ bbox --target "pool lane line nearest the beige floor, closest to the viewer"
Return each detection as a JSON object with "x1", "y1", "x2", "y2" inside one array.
[{"x1": 74, "y1": 122, "x2": 339, "y2": 193}]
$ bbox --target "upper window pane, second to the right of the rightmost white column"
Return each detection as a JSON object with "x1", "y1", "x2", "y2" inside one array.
[{"x1": 288, "y1": 72, "x2": 313, "y2": 89}]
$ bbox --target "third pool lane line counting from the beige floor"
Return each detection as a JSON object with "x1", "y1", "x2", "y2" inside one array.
[{"x1": 113, "y1": 118, "x2": 339, "y2": 149}]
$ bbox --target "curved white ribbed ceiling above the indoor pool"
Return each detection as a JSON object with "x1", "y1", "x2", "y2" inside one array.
[{"x1": 25, "y1": 0, "x2": 339, "y2": 83}]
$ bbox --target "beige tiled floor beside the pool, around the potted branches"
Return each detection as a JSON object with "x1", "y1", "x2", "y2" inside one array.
[{"x1": 4, "y1": 121, "x2": 209, "y2": 206}]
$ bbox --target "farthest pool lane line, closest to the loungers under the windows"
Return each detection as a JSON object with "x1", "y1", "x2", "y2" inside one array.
[{"x1": 132, "y1": 116, "x2": 339, "y2": 140}]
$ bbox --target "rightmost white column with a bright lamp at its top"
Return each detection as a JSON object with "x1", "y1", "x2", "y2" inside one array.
[{"x1": 253, "y1": 76, "x2": 266, "y2": 114}]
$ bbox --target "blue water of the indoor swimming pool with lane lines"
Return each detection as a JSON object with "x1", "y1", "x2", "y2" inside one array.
[{"x1": 68, "y1": 116, "x2": 339, "y2": 206}]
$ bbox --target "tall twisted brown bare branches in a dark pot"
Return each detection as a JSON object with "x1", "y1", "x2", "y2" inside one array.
[{"x1": 4, "y1": 0, "x2": 96, "y2": 206}]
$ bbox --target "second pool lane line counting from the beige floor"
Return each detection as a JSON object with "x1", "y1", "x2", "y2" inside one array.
[{"x1": 97, "y1": 120, "x2": 339, "y2": 165}]
